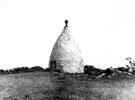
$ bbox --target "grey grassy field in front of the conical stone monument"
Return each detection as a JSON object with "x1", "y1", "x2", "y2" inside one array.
[{"x1": 0, "y1": 72, "x2": 135, "y2": 100}]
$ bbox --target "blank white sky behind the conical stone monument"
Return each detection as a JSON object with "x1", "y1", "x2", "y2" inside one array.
[{"x1": 0, "y1": 0, "x2": 135, "y2": 69}]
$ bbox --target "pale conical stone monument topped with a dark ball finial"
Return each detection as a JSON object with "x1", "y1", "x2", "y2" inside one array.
[{"x1": 49, "y1": 20, "x2": 84, "y2": 73}]
